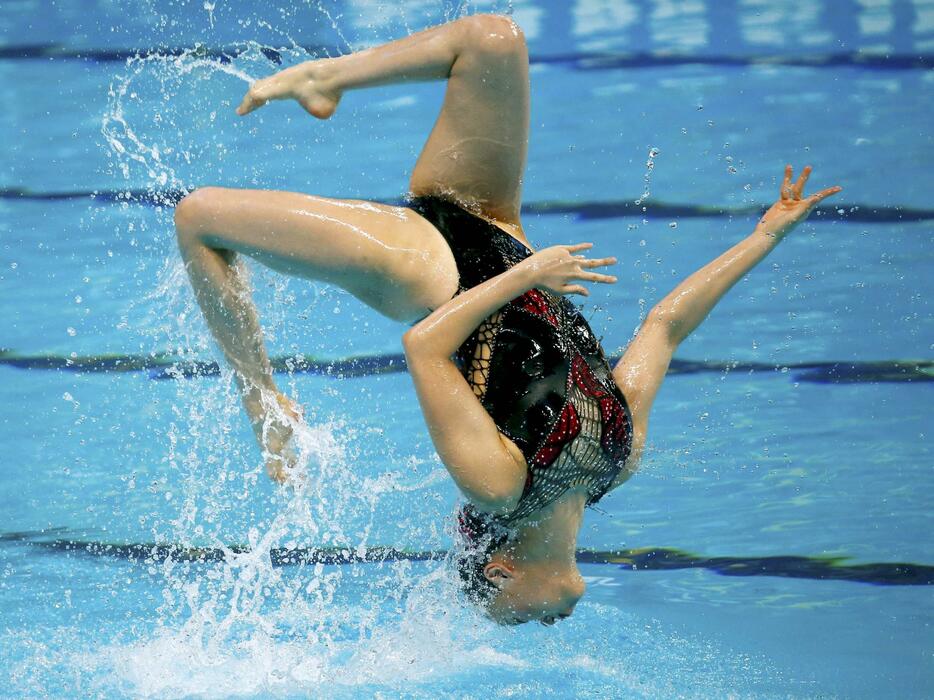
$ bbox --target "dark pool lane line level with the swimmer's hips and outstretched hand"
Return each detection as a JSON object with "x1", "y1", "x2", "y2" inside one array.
[{"x1": 0, "y1": 187, "x2": 934, "y2": 223}]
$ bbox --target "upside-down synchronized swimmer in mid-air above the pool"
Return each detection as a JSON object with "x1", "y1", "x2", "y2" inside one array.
[{"x1": 175, "y1": 15, "x2": 840, "y2": 624}]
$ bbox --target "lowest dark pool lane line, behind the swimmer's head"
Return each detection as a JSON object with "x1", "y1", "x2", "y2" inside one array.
[{"x1": 9, "y1": 533, "x2": 934, "y2": 586}]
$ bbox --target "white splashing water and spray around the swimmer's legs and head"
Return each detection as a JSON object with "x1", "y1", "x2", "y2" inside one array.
[{"x1": 75, "y1": 3, "x2": 784, "y2": 698}]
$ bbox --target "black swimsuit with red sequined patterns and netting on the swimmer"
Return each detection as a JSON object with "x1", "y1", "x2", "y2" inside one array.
[{"x1": 406, "y1": 197, "x2": 632, "y2": 538}]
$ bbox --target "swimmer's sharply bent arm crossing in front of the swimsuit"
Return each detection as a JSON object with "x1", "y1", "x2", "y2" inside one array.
[{"x1": 402, "y1": 244, "x2": 615, "y2": 512}]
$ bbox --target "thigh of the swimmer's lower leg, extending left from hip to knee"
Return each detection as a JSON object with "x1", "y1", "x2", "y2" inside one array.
[{"x1": 176, "y1": 187, "x2": 457, "y2": 321}]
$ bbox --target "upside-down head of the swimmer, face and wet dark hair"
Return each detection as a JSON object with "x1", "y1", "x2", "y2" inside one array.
[{"x1": 457, "y1": 511, "x2": 585, "y2": 625}]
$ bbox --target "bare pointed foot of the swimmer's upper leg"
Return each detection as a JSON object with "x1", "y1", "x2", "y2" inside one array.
[{"x1": 237, "y1": 58, "x2": 341, "y2": 119}]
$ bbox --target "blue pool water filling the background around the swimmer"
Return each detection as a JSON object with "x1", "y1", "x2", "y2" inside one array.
[{"x1": 0, "y1": 0, "x2": 934, "y2": 698}]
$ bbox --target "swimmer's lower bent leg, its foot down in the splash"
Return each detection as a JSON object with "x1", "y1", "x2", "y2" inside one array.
[{"x1": 175, "y1": 188, "x2": 457, "y2": 480}]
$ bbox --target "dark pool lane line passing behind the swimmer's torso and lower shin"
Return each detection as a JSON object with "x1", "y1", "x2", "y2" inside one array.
[{"x1": 0, "y1": 348, "x2": 934, "y2": 384}]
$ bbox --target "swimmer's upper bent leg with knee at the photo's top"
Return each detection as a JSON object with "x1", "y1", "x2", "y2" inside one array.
[{"x1": 238, "y1": 15, "x2": 529, "y2": 225}]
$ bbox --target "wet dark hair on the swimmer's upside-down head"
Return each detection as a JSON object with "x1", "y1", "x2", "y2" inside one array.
[{"x1": 454, "y1": 505, "x2": 512, "y2": 607}]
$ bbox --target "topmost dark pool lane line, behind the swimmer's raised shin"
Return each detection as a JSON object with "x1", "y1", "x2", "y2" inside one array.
[{"x1": 0, "y1": 42, "x2": 934, "y2": 70}]
